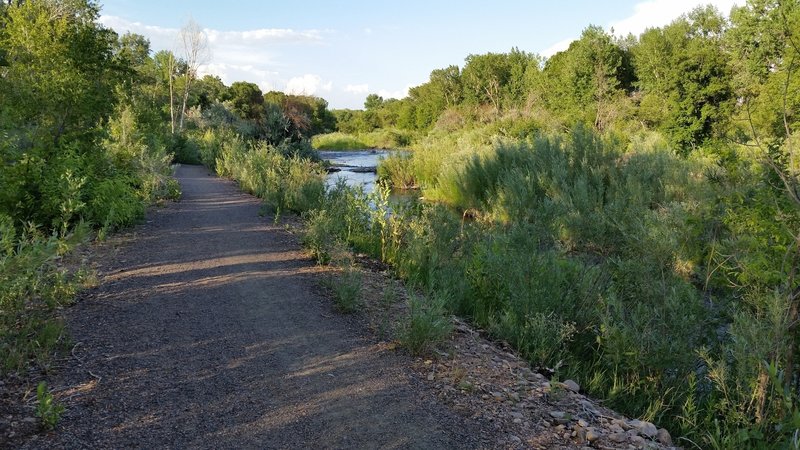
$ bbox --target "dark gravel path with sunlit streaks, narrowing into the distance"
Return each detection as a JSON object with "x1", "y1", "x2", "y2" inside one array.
[{"x1": 20, "y1": 166, "x2": 495, "y2": 448}]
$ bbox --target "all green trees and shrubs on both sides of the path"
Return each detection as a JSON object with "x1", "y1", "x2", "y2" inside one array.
[{"x1": 6, "y1": 0, "x2": 800, "y2": 448}]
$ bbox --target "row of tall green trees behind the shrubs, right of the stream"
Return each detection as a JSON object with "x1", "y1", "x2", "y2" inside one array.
[{"x1": 334, "y1": 0, "x2": 800, "y2": 155}]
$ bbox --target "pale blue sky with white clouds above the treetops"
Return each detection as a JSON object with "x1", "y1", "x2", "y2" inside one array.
[{"x1": 100, "y1": 0, "x2": 744, "y2": 109}]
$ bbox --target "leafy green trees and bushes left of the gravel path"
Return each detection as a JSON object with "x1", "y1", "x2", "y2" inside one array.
[{"x1": 0, "y1": 0, "x2": 335, "y2": 373}]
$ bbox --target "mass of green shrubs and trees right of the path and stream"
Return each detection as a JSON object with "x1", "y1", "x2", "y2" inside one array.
[{"x1": 314, "y1": 0, "x2": 800, "y2": 448}]
